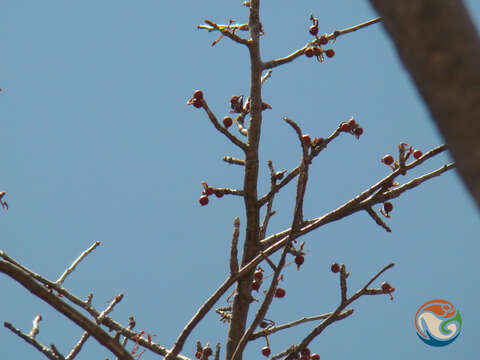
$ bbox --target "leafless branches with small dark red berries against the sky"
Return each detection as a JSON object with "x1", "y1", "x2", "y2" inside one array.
[{"x1": 0, "y1": 0, "x2": 455, "y2": 360}]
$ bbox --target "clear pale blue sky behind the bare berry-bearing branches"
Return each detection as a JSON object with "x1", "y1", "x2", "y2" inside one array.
[{"x1": 0, "y1": 0, "x2": 480, "y2": 360}]
